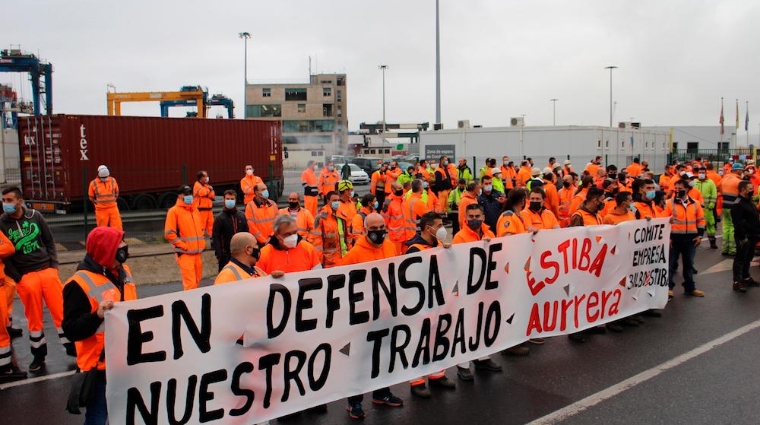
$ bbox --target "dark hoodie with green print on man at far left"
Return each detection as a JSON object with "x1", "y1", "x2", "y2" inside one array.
[{"x1": 0, "y1": 207, "x2": 58, "y2": 282}]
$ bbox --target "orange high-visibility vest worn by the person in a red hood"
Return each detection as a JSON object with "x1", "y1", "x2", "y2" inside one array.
[{"x1": 66, "y1": 265, "x2": 137, "y2": 372}]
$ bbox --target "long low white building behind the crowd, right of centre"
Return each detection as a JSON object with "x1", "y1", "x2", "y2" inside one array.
[{"x1": 420, "y1": 126, "x2": 670, "y2": 174}]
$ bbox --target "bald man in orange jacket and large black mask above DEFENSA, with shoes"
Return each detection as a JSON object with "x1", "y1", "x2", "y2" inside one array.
[{"x1": 340, "y1": 210, "x2": 404, "y2": 419}]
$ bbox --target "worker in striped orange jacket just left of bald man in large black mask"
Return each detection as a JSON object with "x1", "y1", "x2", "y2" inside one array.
[{"x1": 311, "y1": 191, "x2": 350, "y2": 268}]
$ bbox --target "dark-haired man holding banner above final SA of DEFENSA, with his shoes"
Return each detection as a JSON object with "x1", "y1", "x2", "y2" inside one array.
[{"x1": 405, "y1": 212, "x2": 458, "y2": 398}]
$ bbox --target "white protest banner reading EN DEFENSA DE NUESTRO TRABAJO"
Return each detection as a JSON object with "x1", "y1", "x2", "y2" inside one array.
[{"x1": 106, "y1": 219, "x2": 670, "y2": 425}]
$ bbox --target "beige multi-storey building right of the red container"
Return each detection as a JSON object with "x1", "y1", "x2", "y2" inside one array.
[{"x1": 245, "y1": 74, "x2": 348, "y2": 169}]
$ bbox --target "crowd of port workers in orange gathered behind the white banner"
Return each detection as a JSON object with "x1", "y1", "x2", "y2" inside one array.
[{"x1": 0, "y1": 156, "x2": 760, "y2": 423}]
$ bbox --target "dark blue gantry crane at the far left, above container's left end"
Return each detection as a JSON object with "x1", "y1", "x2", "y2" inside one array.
[{"x1": 0, "y1": 49, "x2": 53, "y2": 115}]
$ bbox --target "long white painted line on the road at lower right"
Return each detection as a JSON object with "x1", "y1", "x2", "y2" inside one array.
[{"x1": 528, "y1": 320, "x2": 760, "y2": 425}]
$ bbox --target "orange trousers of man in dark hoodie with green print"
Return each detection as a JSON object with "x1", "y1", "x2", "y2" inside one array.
[{"x1": 16, "y1": 267, "x2": 69, "y2": 357}]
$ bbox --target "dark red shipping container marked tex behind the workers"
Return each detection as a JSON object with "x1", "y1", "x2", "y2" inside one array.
[{"x1": 19, "y1": 115, "x2": 283, "y2": 211}]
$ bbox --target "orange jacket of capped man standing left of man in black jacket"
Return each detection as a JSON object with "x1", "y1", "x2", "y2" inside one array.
[{"x1": 164, "y1": 199, "x2": 206, "y2": 255}]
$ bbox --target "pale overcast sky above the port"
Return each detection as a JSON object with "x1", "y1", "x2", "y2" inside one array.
[{"x1": 0, "y1": 0, "x2": 760, "y2": 140}]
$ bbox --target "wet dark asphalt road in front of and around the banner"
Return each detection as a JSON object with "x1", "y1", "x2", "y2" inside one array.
[{"x1": 0, "y1": 237, "x2": 760, "y2": 425}]
